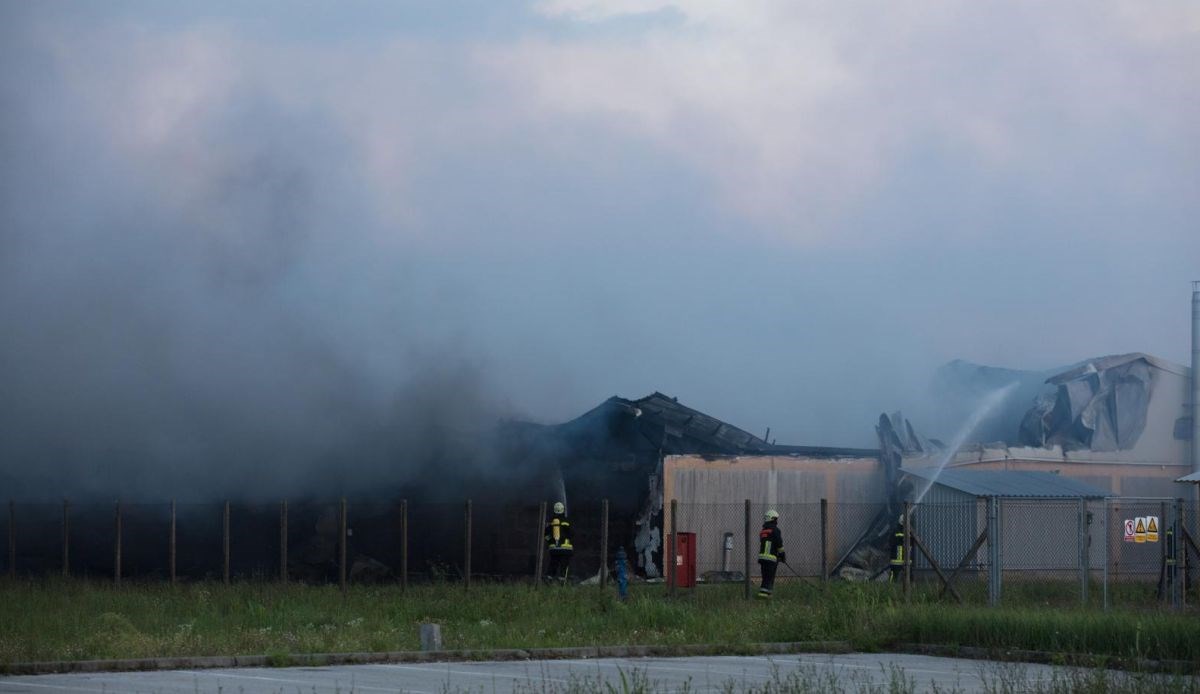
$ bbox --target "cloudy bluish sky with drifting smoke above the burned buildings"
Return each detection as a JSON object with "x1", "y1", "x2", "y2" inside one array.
[{"x1": 0, "y1": 0, "x2": 1200, "y2": 494}]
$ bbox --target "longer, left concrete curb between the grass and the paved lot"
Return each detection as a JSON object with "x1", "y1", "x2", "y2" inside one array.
[{"x1": 0, "y1": 641, "x2": 851, "y2": 675}]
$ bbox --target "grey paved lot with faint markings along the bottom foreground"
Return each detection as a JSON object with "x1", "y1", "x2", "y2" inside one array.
[{"x1": 0, "y1": 653, "x2": 1132, "y2": 694}]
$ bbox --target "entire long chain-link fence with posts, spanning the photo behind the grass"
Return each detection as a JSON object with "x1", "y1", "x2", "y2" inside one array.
[{"x1": 0, "y1": 497, "x2": 1200, "y2": 609}]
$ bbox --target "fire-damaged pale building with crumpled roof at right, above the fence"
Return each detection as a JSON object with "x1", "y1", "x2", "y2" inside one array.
[{"x1": 904, "y1": 352, "x2": 1192, "y2": 497}]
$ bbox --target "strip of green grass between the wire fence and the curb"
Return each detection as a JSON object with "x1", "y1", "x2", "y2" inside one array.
[{"x1": 0, "y1": 571, "x2": 1200, "y2": 665}]
